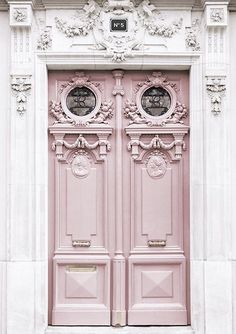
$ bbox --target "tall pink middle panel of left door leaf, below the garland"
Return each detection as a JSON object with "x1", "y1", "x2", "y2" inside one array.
[{"x1": 55, "y1": 150, "x2": 106, "y2": 252}]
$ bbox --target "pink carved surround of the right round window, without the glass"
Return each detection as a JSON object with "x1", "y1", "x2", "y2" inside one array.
[{"x1": 124, "y1": 72, "x2": 188, "y2": 126}]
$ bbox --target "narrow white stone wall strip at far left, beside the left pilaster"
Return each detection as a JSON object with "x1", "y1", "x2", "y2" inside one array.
[{"x1": 0, "y1": 12, "x2": 10, "y2": 333}]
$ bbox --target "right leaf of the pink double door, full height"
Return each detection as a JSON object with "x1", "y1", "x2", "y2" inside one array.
[{"x1": 124, "y1": 72, "x2": 189, "y2": 325}]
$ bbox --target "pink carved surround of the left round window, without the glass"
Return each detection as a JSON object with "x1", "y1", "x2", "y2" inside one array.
[{"x1": 49, "y1": 73, "x2": 113, "y2": 126}]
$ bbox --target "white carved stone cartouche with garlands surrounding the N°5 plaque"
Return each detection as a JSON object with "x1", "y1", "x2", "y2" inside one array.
[{"x1": 55, "y1": 0, "x2": 183, "y2": 62}]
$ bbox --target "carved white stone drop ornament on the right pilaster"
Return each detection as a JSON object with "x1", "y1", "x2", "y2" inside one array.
[{"x1": 206, "y1": 77, "x2": 226, "y2": 115}]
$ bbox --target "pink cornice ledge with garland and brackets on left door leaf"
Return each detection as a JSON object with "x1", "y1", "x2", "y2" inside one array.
[{"x1": 49, "y1": 126, "x2": 112, "y2": 161}]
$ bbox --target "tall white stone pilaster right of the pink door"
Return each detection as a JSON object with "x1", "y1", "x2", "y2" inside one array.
[{"x1": 203, "y1": 2, "x2": 232, "y2": 334}]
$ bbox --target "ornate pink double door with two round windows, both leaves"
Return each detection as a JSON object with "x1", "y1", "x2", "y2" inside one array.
[{"x1": 49, "y1": 70, "x2": 189, "y2": 326}]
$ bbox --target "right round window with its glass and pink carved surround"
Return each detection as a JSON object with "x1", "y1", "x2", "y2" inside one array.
[{"x1": 124, "y1": 72, "x2": 188, "y2": 126}]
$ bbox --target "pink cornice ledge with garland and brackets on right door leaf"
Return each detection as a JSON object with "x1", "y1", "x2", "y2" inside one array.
[{"x1": 126, "y1": 126, "x2": 188, "y2": 160}]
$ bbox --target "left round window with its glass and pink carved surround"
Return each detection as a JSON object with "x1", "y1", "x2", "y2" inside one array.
[{"x1": 49, "y1": 72, "x2": 113, "y2": 126}]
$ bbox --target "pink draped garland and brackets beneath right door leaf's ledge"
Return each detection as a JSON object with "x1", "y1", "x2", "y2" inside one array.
[{"x1": 127, "y1": 134, "x2": 186, "y2": 160}]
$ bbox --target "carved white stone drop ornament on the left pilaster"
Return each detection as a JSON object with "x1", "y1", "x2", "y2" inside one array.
[{"x1": 11, "y1": 76, "x2": 31, "y2": 115}]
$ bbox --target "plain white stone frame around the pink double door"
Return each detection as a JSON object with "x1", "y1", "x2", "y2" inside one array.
[{"x1": 34, "y1": 52, "x2": 205, "y2": 333}]
